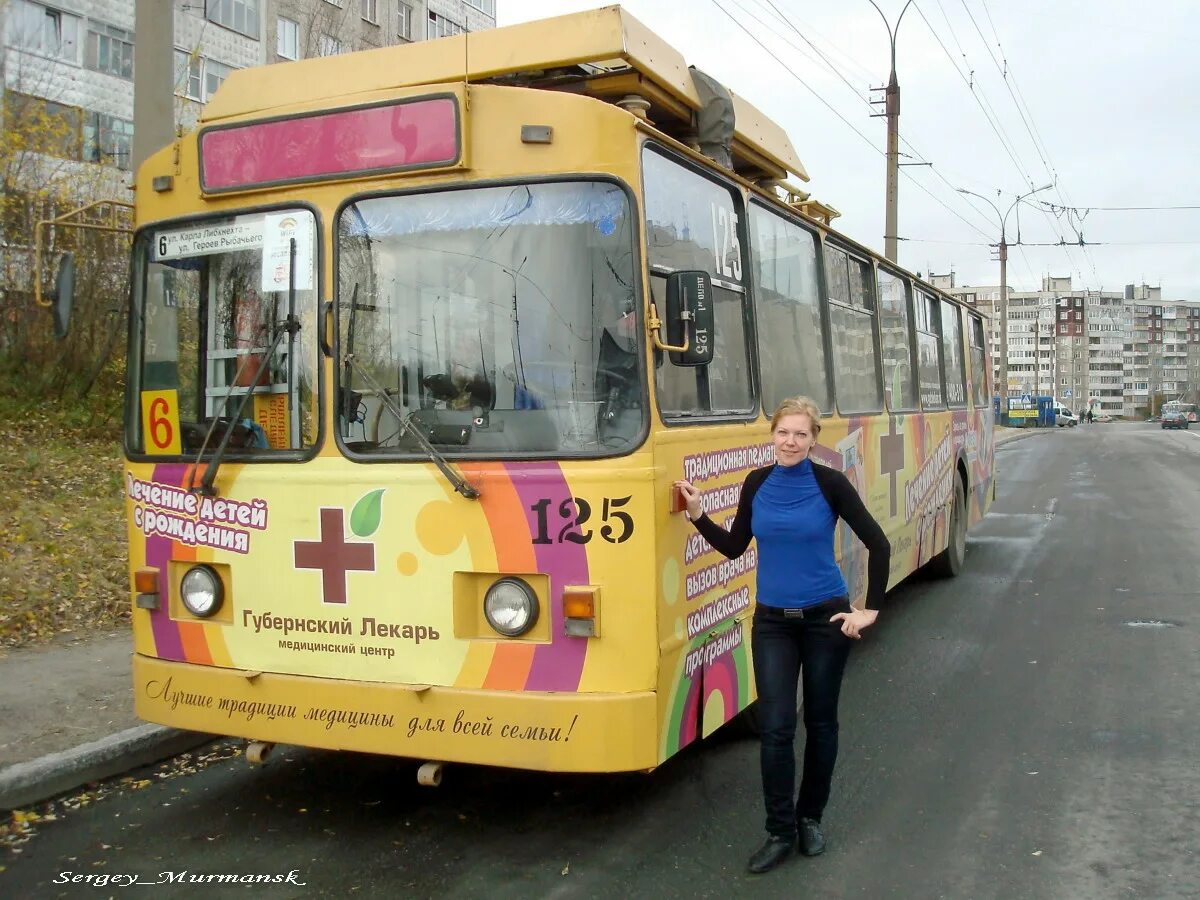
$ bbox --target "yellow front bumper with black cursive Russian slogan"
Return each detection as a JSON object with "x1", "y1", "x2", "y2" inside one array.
[{"x1": 133, "y1": 653, "x2": 658, "y2": 772}]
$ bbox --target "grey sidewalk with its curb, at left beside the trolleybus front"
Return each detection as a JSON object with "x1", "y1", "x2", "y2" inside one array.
[{"x1": 0, "y1": 631, "x2": 211, "y2": 810}]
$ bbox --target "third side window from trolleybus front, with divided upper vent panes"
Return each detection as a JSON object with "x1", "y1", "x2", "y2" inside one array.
[{"x1": 824, "y1": 244, "x2": 883, "y2": 413}]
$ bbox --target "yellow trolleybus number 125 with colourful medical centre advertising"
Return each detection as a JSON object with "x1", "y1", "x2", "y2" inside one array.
[{"x1": 112, "y1": 7, "x2": 994, "y2": 780}]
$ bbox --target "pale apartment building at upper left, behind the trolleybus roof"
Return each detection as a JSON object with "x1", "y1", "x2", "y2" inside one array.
[{"x1": 0, "y1": 0, "x2": 496, "y2": 172}]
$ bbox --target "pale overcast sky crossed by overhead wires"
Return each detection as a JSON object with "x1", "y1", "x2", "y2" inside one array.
[{"x1": 497, "y1": 0, "x2": 1200, "y2": 300}]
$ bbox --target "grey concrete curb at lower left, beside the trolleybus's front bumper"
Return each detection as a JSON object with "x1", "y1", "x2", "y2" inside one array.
[{"x1": 0, "y1": 725, "x2": 217, "y2": 811}]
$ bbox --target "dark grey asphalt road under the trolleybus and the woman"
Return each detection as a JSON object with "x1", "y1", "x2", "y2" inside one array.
[{"x1": 0, "y1": 425, "x2": 1200, "y2": 900}]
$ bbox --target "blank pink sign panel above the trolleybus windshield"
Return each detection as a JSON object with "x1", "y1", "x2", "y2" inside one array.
[{"x1": 200, "y1": 95, "x2": 462, "y2": 193}]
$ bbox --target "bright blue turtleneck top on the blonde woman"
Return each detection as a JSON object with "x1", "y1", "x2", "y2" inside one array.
[{"x1": 751, "y1": 460, "x2": 847, "y2": 608}]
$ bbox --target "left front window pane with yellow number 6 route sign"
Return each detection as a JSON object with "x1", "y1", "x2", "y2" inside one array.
[{"x1": 128, "y1": 210, "x2": 319, "y2": 455}]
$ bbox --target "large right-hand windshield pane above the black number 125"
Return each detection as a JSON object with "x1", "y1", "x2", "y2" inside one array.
[{"x1": 337, "y1": 180, "x2": 646, "y2": 457}]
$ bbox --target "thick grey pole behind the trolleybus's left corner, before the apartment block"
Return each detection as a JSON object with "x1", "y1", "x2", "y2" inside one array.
[{"x1": 130, "y1": 0, "x2": 175, "y2": 178}]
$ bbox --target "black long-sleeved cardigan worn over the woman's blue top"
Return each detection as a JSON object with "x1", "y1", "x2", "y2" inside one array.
[{"x1": 692, "y1": 461, "x2": 892, "y2": 610}]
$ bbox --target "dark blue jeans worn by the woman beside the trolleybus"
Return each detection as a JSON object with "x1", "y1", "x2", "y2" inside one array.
[{"x1": 750, "y1": 598, "x2": 851, "y2": 840}]
